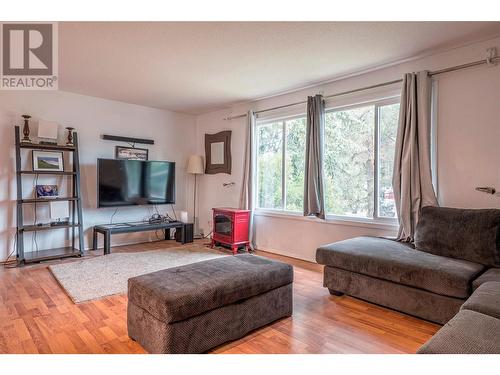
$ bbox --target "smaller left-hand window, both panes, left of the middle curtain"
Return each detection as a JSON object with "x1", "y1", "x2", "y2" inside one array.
[{"x1": 255, "y1": 116, "x2": 306, "y2": 212}]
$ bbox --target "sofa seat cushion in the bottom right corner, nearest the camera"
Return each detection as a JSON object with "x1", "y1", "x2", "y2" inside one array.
[{"x1": 418, "y1": 310, "x2": 500, "y2": 354}]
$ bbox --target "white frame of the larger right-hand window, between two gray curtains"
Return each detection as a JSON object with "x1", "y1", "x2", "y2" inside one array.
[{"x1": 325, "y1": 95, "x2": 401, "y2": 225}]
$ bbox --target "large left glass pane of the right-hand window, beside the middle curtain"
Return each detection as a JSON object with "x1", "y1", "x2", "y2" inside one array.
[{"x1": 324, "y1": 105, "x2": 375, "y2": 218}]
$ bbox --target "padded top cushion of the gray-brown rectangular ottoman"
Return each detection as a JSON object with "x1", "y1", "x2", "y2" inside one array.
[{"x1": 128, "y1": 254, "x2": 293, "y2": 323}]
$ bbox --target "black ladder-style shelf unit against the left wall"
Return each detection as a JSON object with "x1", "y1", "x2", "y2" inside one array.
[{"x1": 15, "y1": 126, "x2": 83, "y2": 264}]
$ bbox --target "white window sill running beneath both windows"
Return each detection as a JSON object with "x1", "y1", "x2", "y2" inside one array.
[{"x1": 254, "y1": 209, "x2": 399, "y2": 231}]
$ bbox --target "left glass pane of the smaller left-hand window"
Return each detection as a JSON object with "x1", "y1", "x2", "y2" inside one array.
[{"x1": 256, "y1": 122, "x2": 283, "y2": 209}]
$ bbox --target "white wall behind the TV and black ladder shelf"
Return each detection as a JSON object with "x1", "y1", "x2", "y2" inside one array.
[{"x1": 0, "y1": 91, "x2": 196, "y2": 260}]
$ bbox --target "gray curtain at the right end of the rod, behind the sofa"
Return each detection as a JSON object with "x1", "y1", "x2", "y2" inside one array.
[{"x1": 392, "y1": 72, "x2": 437, "y2": 242}]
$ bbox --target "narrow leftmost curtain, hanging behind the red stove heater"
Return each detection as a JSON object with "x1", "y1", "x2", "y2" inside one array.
[{"x1": 240, "y1": 111, "x2": 255, "y2": 249}]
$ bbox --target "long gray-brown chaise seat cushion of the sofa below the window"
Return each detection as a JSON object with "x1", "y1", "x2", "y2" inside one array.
[{"x1": 316, "y1": 237, "x2": 484, "y2": 298}]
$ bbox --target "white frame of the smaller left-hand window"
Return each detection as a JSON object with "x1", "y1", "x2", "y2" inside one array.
[{"x1": 254, "y1": 113, "x2": 307, "y2": 215}]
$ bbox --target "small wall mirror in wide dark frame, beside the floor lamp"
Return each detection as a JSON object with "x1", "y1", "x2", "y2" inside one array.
[{"x1": 205, "y1": 130, "x2": 231, "y2": 174}]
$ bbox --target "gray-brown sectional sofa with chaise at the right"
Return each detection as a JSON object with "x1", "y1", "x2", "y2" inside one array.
[{"x1": 316, "y1": 207, "x2": 500, "y2": 353}]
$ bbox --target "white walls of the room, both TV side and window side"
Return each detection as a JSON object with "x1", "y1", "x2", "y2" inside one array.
[{"x1": 0, "y1": 38, "x2": 500, "y2": 260}]
